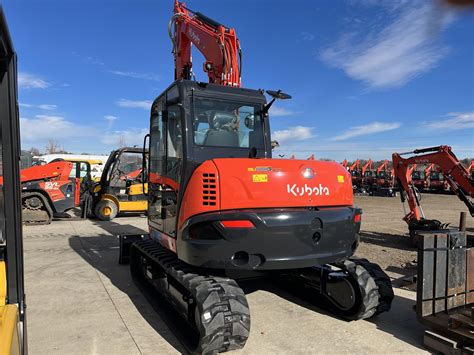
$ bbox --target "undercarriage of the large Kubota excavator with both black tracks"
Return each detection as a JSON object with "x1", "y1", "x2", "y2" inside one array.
[{"x1": 120, "y1": 235, "x2": 394, "y2": 353}]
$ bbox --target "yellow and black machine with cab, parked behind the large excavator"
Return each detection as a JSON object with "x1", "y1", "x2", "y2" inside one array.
[{"x1": 93, "y1": 148, "x2": 148, "y2": 221}]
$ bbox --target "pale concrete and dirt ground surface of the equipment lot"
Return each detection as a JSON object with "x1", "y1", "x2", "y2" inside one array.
[{"x1": 24, "y1": 194, "x2": 474, "y2": 354}]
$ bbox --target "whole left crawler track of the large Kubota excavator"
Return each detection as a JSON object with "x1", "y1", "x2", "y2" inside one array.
[{"x1": 130, "y1": 239, "x2": 250, "y2": 354}]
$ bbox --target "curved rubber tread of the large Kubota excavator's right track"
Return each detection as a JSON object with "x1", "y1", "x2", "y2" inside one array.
[{"x1": 343, "y1": 258, "x2": 394, "y2": 319}]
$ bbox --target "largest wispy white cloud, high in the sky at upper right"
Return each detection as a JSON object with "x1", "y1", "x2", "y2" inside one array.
[{"x1": 320, "y1": 2, "x2": 452, "y2": 89}]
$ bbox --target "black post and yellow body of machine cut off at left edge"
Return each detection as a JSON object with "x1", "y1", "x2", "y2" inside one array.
[{"x1": 0, "y1": 7, "x2": 27, "y2": 354}]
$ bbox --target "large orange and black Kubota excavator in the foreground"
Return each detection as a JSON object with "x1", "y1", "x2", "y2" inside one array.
[{"x1": 120, "y1": 1, "x2": 393, "y2": 353}]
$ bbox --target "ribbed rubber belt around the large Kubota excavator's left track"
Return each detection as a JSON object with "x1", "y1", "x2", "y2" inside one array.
[{"x1": 134, "y1": 240, "x2": 250, "y2": 354}]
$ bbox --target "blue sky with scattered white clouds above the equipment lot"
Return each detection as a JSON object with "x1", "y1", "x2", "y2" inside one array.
[{"x1": 2, "y1": 0, "x2": 474, "y2": 160}]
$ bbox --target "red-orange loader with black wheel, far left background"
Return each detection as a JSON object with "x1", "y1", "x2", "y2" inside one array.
[{"x1": 0, "y1": 161, "x2": 90, "y2": 224}]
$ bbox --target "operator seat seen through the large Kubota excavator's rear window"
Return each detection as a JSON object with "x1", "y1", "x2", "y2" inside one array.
[{"x1": 203, "y1": 111, "x2": 239, "y2": 147}]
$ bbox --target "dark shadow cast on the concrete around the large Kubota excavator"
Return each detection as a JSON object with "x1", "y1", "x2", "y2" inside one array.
[{"x1": 69, "y1": 228, "x2": 421, "y2": 353}]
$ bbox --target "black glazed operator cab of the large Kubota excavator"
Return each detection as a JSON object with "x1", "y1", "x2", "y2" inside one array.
[{"x1": 148, "y1": 80, "x2": 271, "y2": 237}]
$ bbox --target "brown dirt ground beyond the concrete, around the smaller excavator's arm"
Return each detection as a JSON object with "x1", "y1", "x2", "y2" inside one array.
[{"x1": 355, "y1": 193, "x2": 474, "y2": 278}]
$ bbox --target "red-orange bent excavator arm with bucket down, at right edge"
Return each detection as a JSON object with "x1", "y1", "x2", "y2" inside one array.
[{"x1": 392, "y1": 146, "x2": 474, "y2": 233}]
